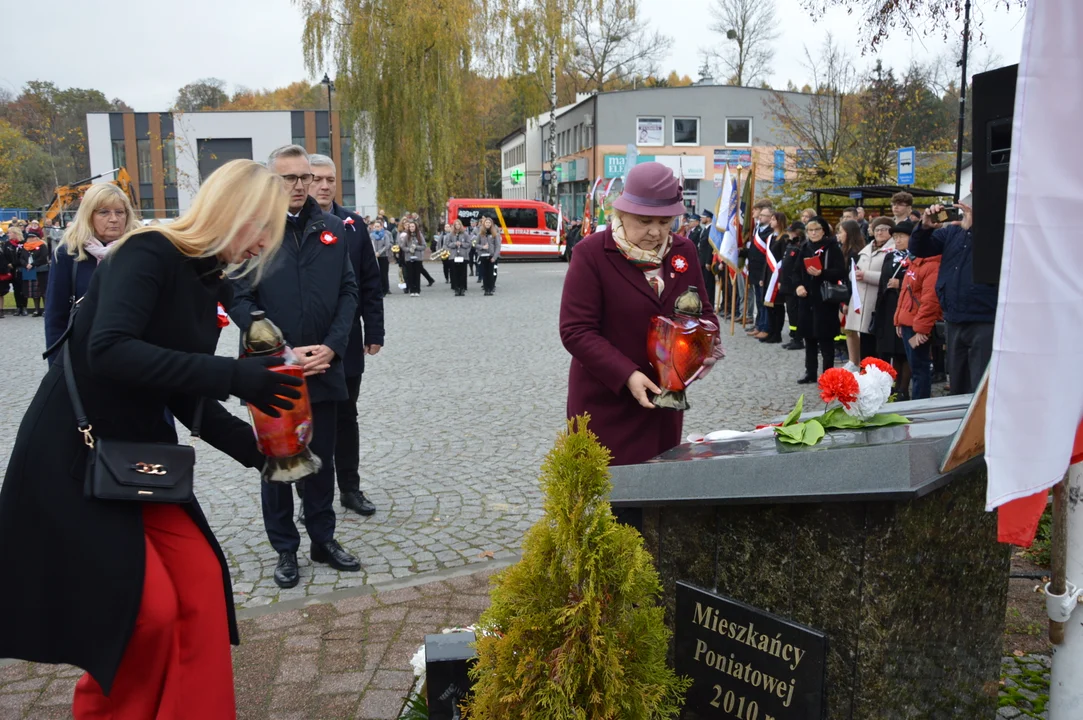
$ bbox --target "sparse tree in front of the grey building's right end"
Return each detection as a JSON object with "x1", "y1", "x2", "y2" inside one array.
[{"x1": 766, "y1": 35, "x2": 858, "y2": 178}]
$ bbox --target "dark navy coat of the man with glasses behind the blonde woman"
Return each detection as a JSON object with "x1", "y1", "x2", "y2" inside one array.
[{"x1": 226, "y1": 197, "x2": 357, "y2": 403}]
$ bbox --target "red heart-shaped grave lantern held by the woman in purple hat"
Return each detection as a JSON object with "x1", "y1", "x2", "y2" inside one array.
[{"x1": 647, "y1": 287, "x2": 718, "y2": 410}]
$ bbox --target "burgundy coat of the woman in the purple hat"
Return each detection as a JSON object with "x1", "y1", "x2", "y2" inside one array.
[{"x1": 560, "y1": 230, "x2": 718, "y2": 466}]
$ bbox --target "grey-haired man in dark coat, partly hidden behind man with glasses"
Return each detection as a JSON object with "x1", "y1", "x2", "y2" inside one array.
[{"x1": 309, "y1": 155, "x2": 383, "y2": 515}]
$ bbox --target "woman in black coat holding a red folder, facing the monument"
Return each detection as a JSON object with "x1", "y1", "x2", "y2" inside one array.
[{"x1": 795, "y1": 215, "x2": 847, "y2": 384}]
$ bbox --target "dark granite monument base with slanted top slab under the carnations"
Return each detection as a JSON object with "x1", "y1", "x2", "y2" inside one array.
[{"x1": 614, "y1": 403, "x2": 1009, "y2": 720}]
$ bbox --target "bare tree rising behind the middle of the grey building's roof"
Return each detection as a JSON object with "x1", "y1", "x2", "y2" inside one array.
[{"x1": 706, "y1": 0, "x2": 779, "y2": 87}]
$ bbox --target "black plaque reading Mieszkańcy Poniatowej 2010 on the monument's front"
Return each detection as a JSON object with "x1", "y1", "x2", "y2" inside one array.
[{"x1": 674, "y1": 582, "x2": 827, "y2": 720}]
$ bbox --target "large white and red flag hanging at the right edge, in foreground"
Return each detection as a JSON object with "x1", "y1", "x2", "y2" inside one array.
[{"x1": 978, "y1": 0, "x2": 1083, "y2": 545}]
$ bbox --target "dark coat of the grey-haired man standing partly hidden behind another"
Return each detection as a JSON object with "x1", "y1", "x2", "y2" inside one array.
[{"x1": 331, "y1": 202, "x2": 383, "y2": 378}]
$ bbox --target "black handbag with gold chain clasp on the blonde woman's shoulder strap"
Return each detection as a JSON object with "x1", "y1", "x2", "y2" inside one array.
[{"x1": 47, "y1": 302, "x2": 204, "y2": 503}]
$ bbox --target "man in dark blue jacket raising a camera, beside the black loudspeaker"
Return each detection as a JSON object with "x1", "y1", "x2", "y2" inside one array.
[{"x1": 910, "y1": 202, "x2": 997, "y2": 395}]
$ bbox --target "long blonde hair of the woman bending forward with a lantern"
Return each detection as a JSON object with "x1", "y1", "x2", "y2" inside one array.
[{"x1": 117, "y1": 160, "x2": 289, "y2": 282}]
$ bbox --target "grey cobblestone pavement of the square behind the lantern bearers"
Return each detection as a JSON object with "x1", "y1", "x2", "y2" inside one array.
[{"x1": 0, "y1": 263, "x2": 803, "y2": 607}]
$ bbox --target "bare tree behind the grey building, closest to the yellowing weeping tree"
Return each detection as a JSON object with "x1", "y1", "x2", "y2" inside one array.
[{"x1": 567, "y1": 0, "x2": 673, "y2": 92}]
